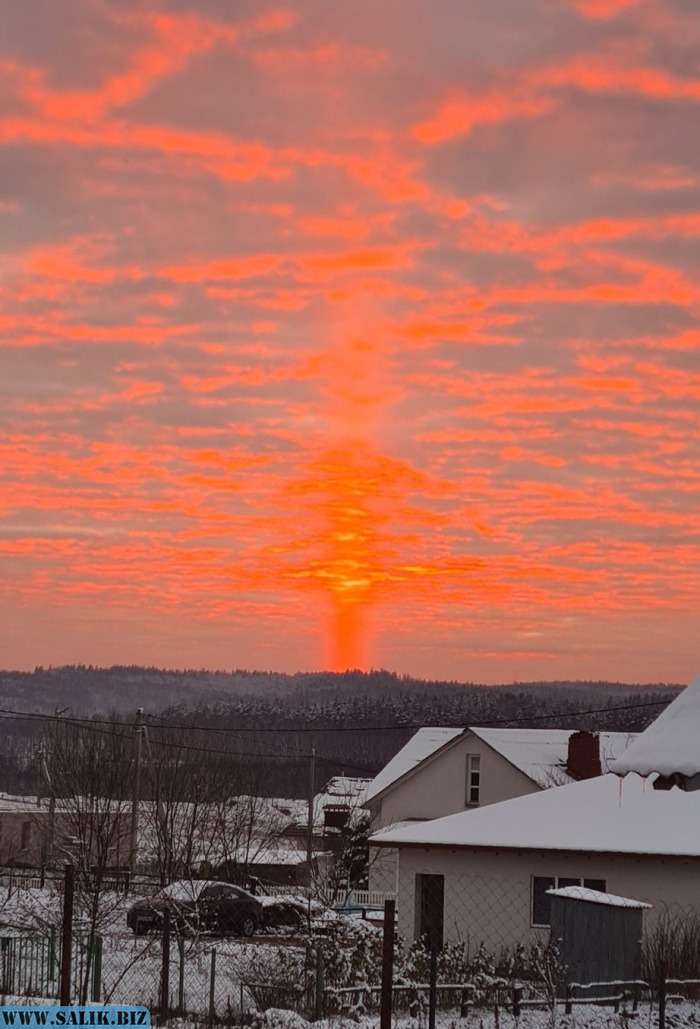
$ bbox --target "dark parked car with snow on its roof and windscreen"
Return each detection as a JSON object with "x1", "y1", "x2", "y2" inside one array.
[{"x1": 127, "y1": 879, "x2": 263, "y2": 936}]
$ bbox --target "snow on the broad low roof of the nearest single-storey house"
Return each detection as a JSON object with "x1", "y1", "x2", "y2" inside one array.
[{"x1": 371, "y1": 774, "x2": 700, "y2": 857}]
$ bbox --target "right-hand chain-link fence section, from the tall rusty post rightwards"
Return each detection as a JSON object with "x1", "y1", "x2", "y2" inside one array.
[{"x1": 380, "y1": 868, "x2": 700, "y2": 1029}]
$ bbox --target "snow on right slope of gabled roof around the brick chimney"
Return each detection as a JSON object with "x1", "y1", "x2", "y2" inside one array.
[{"x1": 471, "y1": 726, "x2": 635, "y2": 787}]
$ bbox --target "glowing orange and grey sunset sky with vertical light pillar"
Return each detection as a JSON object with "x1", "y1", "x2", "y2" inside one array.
[{"x1": 0, "y1": 0, "x2": 700, "y2": 682}]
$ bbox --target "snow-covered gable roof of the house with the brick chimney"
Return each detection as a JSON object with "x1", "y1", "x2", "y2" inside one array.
[{"x1": 365, "y1": 725, "x2": 635, "y2": 802}]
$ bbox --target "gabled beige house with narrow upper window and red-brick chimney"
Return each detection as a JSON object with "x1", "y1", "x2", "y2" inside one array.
[{"x1": 364, "y1": 726, "x2": 634, "y2": 892}]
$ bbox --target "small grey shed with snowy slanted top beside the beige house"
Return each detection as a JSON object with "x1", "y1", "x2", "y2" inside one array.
[{"x1": 548, "y1": 886, "x2": 652, "y2": 984}]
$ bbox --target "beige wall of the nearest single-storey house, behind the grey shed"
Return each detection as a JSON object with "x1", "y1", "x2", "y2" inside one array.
[{"x1": 397, "y1": 847, "x2": 700, "y2": 951}]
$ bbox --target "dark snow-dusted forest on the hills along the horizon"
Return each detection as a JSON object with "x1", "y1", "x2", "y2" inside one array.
[{"x1": 0, "y1": 665, "x2": 681, "y2": 796}]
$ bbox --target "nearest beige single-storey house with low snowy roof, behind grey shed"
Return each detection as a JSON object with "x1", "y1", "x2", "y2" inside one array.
[{"x1": 372, "y1": 774, "x2": 700, "y2": 950}]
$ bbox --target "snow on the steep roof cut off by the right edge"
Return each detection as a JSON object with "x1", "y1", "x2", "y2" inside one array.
[{"x1": 611, "y1": 676, "x2": 700, "y2": 778}]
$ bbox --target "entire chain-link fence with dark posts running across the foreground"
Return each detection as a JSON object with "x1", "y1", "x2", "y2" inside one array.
[{"x1": 5, "y1": 859, "x2": 700, "y2": 1029}]
